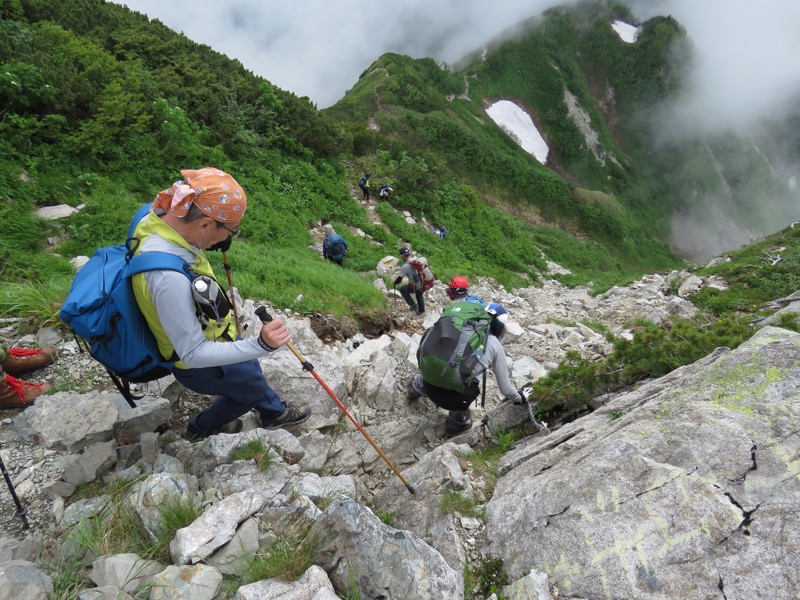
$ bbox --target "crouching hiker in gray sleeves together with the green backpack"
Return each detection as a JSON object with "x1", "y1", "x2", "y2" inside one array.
[{"x1": 408, "y1": 302, "x2": 525, "y2": 437}]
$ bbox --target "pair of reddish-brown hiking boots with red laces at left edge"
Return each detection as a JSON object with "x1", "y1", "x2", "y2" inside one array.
[{"x1": 0, "y1": 346, "x2": 58, "y2": 408}]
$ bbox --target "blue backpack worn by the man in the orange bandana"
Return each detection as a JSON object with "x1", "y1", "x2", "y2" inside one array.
[{"x1": 59, "y1": 204, "x2": 194, "y2": 408}]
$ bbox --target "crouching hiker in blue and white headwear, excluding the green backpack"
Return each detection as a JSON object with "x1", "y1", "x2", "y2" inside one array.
[{"x1": 408, "y1": 304, "x2": 524, "y2": 437}]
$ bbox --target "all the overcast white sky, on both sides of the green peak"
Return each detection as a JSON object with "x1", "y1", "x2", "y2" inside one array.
[{"x1": 117, "y1": 0, "x2": 800, "y2": 127}]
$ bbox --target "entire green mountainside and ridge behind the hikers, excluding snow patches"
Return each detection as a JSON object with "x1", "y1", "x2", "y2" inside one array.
[{"x1": 0, "y1": 0, "x2": 797, "y2": 322}]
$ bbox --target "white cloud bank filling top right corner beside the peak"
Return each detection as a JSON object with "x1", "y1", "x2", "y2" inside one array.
[{"x1": 632, "y1": 0, "x2": 800, "y2": 133}]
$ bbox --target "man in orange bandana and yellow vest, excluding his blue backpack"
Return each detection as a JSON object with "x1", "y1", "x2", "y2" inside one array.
[{"x1": 131, "y1": 167, "x2": 310, "y2": 440}]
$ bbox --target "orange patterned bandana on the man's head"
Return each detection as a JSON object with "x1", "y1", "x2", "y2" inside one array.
[{"x1": 153, "y1": 167, "x2": 247, "y2": 223}]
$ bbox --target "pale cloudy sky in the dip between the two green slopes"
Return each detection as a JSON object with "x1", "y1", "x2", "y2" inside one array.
[{"x1": 120, "y1": 0, "x2": 564, "y2": 108}]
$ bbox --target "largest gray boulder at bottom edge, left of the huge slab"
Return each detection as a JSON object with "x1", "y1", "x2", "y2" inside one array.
[{"x1": 309, "y1": 496, "x2": 464, "y2": 600}]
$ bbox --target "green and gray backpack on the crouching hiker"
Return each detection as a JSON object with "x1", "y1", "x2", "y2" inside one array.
[{"x1": 417, "y1": 302, "x2": 492, "y2": 395}]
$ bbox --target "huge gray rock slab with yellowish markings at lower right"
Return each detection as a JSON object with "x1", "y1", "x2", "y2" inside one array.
[{"x1": 483, "y1": 328, "x2": 800, "y2": 599}]
